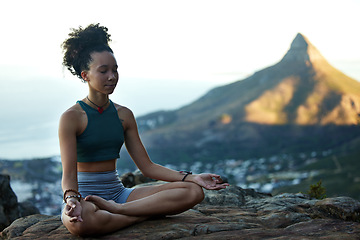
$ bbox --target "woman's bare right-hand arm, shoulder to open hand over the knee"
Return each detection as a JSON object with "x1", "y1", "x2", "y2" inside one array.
[{"x1": 121, "y1": 108, "x2": 228, "y2": 190}]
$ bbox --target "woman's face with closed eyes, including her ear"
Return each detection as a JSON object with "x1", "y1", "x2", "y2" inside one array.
[{"x1": 81, "y1": 51, "x2": 119, "y2": 94}]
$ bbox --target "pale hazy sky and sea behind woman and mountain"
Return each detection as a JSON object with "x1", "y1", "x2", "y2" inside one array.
[{"x1": 0, "y1": 0, "x2": 360, "y2": 159}]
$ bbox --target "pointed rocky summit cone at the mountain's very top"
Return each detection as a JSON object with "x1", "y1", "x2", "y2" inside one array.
[{"x1": 281, "y1": 33, "x2": 326, "y2": 65}]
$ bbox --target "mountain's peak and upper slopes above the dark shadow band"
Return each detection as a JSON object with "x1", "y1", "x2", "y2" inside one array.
[{"x1": 139, "y1": 34, "x2": 360, "y2": 129}]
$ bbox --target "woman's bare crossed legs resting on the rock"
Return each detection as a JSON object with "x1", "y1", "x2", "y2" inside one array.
[{"x1": 63, "y1": 182, "x2": 204, "y2": 236}]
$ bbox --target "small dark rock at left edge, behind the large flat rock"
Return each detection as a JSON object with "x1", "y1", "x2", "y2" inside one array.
[{"x1": 0, "y1": 174, "x2": 39, "y2": 231}]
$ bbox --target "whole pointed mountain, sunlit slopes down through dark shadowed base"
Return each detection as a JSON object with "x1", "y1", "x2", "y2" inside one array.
[{"x1": 132, "y1": 34, "x2": 360, "y2": 162}]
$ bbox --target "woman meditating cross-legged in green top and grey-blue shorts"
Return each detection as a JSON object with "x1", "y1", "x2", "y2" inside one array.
[{"x1": 59, "y1": 24, "x2": 228, "y2": 235}]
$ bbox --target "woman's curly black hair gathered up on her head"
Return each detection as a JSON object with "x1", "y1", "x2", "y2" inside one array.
[{"x1": 61, "y1": 23, "x2": 113, "y2": 79}]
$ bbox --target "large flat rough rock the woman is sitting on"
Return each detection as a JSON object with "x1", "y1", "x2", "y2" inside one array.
[{"x1": 2, "y1": 186, "x2": 360, "y2": 240}]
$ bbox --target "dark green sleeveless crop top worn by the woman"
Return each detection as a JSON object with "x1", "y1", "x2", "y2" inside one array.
[{"x1": 76, "y1": 100, "x2": 124, "y2": 162}]
